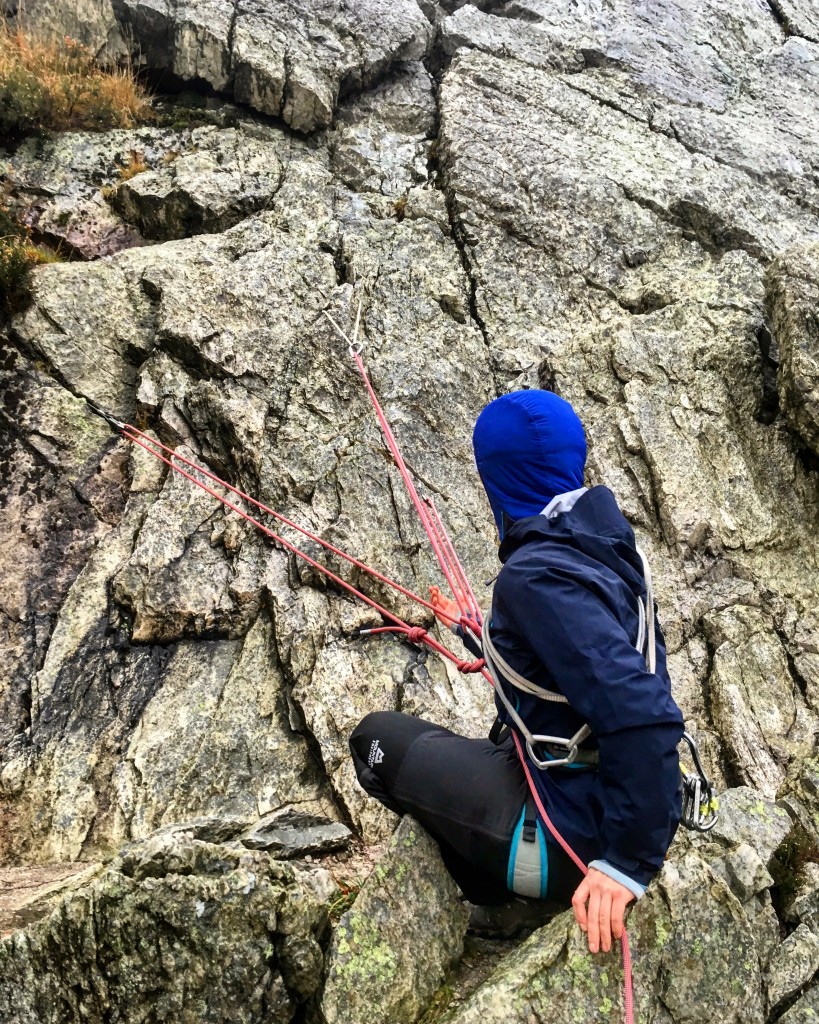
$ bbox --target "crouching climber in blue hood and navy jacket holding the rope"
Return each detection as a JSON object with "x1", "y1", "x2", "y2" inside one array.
[{"x1": 350, "y1": 390, "x2": 683, "y2": 952}]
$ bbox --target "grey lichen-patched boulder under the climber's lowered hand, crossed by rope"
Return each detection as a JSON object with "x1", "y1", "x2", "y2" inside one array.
[{"x1": 447, "y1": 854, "x2": 764, "y2": 1024}]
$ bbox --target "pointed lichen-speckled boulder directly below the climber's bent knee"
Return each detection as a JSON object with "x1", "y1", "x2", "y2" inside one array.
[{"x1": 321, "y1": 817, "x2": 468, "y2": 1024}]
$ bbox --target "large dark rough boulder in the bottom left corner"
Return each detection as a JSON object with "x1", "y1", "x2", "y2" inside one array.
[{"x1": 0, "y1": 837, "x2": 327, "y2": 1024}]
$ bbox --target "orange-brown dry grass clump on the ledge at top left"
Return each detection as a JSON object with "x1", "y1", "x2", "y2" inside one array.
[{"x1": 0, "y1": 26, "x2": 152, "y2": 134}]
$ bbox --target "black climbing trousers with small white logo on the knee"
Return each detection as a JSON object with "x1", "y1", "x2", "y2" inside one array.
[{"x1": 350, "y1": 711, "x2": 581, "y2": 905}]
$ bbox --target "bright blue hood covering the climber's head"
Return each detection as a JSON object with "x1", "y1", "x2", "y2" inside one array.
[{"x1": 472, "y1": 391, "x2": 586, "y2": 539}]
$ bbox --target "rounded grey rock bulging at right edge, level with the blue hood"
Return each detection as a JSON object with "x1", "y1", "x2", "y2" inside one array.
[{"x1": 766, "y1": 244, "x2": 819, "y2": 455}]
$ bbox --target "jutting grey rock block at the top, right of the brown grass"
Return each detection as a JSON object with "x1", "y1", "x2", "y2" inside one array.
[{"x1": 114, "y1": 0, "x2": 432, "y2": 132}]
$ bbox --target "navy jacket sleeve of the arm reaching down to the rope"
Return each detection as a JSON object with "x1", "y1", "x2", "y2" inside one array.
[{"x1": 495, "y1": 564, "x2": 683, "y2": 885}]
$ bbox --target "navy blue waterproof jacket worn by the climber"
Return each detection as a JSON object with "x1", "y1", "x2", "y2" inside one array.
[{"x1": 483, "y1": 486, "x2": 683, "y2": 885}]
